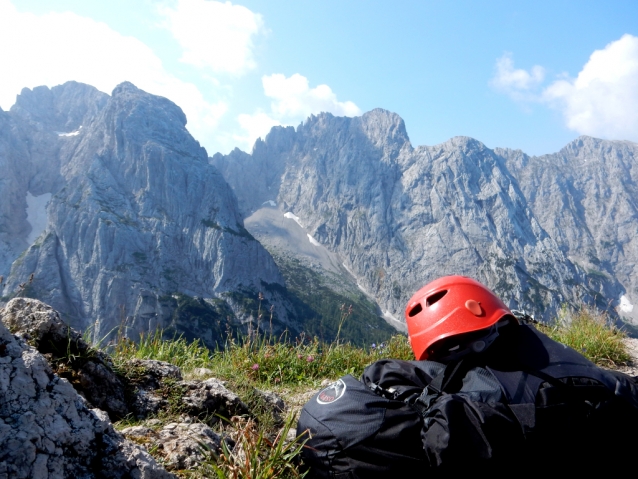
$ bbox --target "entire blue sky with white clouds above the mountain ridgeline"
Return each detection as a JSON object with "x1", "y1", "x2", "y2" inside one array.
[{"x1": 0, "y1": 0, "x2": 638, "y2": 155}]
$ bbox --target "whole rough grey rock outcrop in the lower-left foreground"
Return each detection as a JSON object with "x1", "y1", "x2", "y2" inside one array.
[{"x1": 0, "y1": 298, "x2": 298, "y2": 479}]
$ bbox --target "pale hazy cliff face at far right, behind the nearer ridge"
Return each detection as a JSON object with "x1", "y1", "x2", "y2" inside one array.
[{"x1": 495, "y1": 136, "x2": 638, "y2": 322}]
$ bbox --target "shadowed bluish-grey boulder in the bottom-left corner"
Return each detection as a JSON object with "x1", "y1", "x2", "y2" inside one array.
[{"x1": 0, "y1": 303, "x2": 174, "y2": 479}]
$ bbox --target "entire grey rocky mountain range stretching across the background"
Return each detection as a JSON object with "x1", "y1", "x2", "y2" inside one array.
[{"x1": 0, "y1": 82, "x2": 638, "y2": 344}]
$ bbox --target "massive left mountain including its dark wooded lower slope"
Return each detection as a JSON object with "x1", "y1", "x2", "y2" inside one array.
[{"x1": 0, "y1": 82, "x2": 392, "y2": 347}]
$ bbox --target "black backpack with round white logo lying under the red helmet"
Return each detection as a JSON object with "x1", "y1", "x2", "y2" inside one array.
[{"x1": 297, "y1": 326, "x2": 638, "y2": 479}]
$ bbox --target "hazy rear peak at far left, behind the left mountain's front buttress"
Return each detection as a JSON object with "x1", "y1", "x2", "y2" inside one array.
[{"x1": 0, "y1": 82, "x2": 108, "y2": 280}]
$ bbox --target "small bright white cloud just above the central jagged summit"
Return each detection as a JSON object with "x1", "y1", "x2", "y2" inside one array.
[{"x1": 236, "y1": 73, "x2": 361, "y2": 149}]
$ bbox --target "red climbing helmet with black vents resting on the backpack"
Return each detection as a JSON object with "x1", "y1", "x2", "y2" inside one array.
[{"x1": 405, "y1": 276, "x2": 516, "y2": 360}]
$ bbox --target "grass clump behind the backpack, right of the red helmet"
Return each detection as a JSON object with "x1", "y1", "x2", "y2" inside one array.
[{"x1": 540, "y1": 305, "x2": 630, "y2": 366}]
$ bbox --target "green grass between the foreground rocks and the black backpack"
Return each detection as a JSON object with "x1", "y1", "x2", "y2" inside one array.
[{"x1": 111, "y1": 331, "x2": 413, "y2": 479}]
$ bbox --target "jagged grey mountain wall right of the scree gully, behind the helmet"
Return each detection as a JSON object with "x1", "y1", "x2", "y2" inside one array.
[{"x1": 210, "y1": 110, "x2": 638, "y2": 319}]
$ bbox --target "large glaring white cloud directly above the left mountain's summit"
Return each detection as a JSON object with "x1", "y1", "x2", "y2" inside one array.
[{"x1": 0, "y1": 0, "x2": 227, "y2": 153}]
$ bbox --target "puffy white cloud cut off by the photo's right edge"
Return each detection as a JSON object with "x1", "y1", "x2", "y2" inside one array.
[{"x1": 543, "y1": 35, "x2": 638, "y2": 141}]
